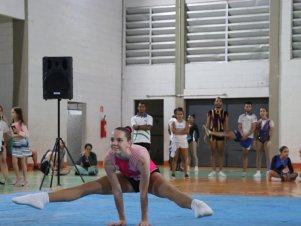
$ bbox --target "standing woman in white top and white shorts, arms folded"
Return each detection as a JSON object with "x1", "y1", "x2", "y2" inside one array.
[{"x1": 171, "y1": 108, "x2": 189, "y2": 178}]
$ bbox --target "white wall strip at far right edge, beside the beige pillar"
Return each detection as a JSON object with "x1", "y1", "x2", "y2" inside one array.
[{"x1": 279, "y1": 1, "x2": 301, "y2": 163}]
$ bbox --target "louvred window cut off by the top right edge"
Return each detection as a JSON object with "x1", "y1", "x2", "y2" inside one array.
[{"x1": 291, "y1": 0, "x2": 301, "y2": 58}]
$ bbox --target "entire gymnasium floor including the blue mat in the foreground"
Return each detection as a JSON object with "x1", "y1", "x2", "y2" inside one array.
[{"x1": 0, "y1": 167, "x2": 301, "y2": 226}]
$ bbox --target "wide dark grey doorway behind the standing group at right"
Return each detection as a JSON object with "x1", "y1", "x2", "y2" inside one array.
[{"x1": 186, "y1": 98, "x2": 269, "y2": 167}]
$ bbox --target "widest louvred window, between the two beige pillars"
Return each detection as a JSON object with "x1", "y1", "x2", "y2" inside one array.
[{"x1": 186, "y1": 0, "x2": 269, "y2": 62}]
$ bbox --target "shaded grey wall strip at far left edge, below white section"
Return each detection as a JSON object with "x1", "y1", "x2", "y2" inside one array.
[{"x1": 0, "y1": 17, "x2": 14, "y2": 115}]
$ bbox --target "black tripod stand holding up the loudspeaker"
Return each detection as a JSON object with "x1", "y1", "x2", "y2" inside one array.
[{"x1": 40, "y1": 99, "x2": 85, "y2": 190}]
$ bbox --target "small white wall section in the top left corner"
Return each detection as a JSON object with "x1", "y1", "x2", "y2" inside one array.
[{"x1": 0, "y1": 0, "x2": 25, "y2": 20}]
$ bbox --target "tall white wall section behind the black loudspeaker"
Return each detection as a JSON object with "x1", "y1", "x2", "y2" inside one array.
[{"x1": 28, "y1": 0, "x2": 122, "y2": 160}]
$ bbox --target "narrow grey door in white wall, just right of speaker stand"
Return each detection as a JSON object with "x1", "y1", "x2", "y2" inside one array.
[{"x1": 67, "y1": 102, "x2": 86, "y2": 165}]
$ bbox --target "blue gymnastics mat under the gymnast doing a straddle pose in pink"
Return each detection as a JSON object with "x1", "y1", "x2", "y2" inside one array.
[{"x1": 0, "y1": 193, "x2": 301, "y2": 226}]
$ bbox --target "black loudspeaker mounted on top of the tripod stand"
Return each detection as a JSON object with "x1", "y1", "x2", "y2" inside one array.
[{"x1": 43, "y1": 57, "x2": 73, "y2": 100}]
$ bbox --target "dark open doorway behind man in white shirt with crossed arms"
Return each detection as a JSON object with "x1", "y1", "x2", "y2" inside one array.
[{"x1": 134, "y1": 100, "x2": 164, "y2": 165}]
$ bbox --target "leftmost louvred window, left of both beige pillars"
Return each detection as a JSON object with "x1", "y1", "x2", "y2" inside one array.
[{"x1": 125, "y1": 5, "x2": 176, "y2": 65}]
